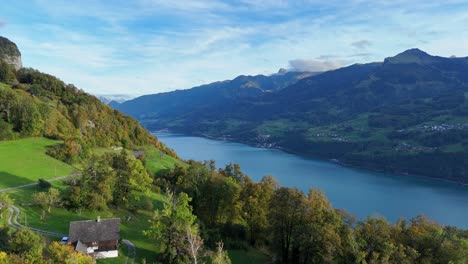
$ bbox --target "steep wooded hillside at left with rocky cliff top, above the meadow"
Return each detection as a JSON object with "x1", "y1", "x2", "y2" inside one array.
[{"x1": 0, "y1": 38, "x2": 175, "y2": 161}]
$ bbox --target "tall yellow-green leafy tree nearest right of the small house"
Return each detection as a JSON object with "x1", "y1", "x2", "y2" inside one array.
[{"x1": 143, "y1": 193, "x2": 197, "y2": 263}]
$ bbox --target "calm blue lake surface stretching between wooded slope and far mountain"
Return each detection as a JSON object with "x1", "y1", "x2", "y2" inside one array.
[{"x1": 156, "y1": 133, "x2": 468, "y2": 229}]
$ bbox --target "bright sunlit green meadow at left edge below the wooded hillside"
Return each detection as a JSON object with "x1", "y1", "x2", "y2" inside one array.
[{"x1": 0, "y1": 138, "x2": 74, "y2": 189}]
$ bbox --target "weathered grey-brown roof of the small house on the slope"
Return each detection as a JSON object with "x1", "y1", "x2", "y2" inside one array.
[{"x1": 68, "y1": 218, "x2": 120, "y2": 243}]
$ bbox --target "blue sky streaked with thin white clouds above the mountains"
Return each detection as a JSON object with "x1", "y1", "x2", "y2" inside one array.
[{"x1": 0, "y1": 0, "x2": 468, "y2": 97}]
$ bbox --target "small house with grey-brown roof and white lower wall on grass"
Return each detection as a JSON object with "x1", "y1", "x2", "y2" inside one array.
[{"x1": 68, "y1": 216, "x2": 120, "y2": 258}]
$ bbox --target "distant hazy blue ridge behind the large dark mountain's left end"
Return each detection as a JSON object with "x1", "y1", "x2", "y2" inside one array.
[{"x1": 113, "y1": 71, "x2": 317, "y2": 120}]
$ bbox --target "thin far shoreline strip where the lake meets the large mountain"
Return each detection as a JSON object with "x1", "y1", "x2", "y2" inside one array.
[{"x1": 151, "y1": 129, "x2": 468, "y2": 188}]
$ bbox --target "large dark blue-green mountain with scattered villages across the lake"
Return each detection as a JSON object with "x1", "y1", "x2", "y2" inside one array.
[{"x1": 121, "y1": 49, "x2": 468, "y2": 184}]
